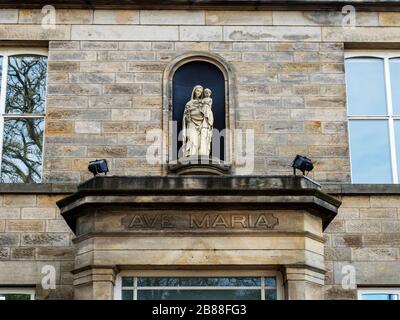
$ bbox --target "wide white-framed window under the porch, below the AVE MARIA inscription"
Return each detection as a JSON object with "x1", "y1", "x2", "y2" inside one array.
[{"x1": 115, "y1": 272, "x2": 283, "y2": 300}]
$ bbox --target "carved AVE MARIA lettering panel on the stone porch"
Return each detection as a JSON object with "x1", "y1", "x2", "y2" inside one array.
[{"x1": 124, "y1": 213, "x2": 279, "y2": 230}]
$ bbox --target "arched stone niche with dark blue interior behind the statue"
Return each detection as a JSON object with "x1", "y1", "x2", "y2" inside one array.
[{"x1": 163, "y1": 52, "x2": 235, "y2": 175}]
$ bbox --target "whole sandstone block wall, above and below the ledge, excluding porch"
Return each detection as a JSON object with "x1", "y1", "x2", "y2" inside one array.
[{"x1": 0, "y1": 9, "x2": 400, "y2": 299}]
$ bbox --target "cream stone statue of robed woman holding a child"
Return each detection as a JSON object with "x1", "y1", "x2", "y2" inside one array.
[{"x1": 182, "y1": 85, "x2": 214, "y2": 157}]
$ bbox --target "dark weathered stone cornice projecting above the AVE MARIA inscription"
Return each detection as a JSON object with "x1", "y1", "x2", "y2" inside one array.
[{"x1": 57, "y1": 176, "x2": 341, "y2": 232}]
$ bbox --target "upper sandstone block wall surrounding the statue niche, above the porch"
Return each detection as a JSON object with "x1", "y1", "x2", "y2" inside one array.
[{"x1": 0, "y1": 9, "x2": 400, "y2": 182}]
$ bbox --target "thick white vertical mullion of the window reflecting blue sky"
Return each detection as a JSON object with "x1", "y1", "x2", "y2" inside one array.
[{"x1": 384, "y1": 57, "x2": 399, "y2": 183}]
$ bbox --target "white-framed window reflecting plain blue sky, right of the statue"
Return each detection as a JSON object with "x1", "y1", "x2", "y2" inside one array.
[{"x1": 345, "y1": 51, "x2": 400, "y2": 183}]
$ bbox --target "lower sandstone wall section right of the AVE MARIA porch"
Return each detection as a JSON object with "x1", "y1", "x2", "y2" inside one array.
[{"x1": 325, "y1": 195, "x2": 400, "y2": 299}]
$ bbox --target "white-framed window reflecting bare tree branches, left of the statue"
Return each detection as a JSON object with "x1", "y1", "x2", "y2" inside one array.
[{"x1": 0, "y1": 48, "x2": 47, "y2": 183}]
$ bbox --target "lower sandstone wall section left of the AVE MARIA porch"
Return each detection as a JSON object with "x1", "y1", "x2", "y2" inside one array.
[{"x1": 0, "y1": 194, "x2": 74, "y2": 299}]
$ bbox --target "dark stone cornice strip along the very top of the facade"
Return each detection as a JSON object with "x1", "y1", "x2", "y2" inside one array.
[{"x1": 0, "y1": 0, "x2": 400, "y2": 11}]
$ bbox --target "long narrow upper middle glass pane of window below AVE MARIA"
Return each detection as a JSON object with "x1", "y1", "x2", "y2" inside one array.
[{"x1": 138, "y1": 277, "x2": 261, "y2": 287}]
